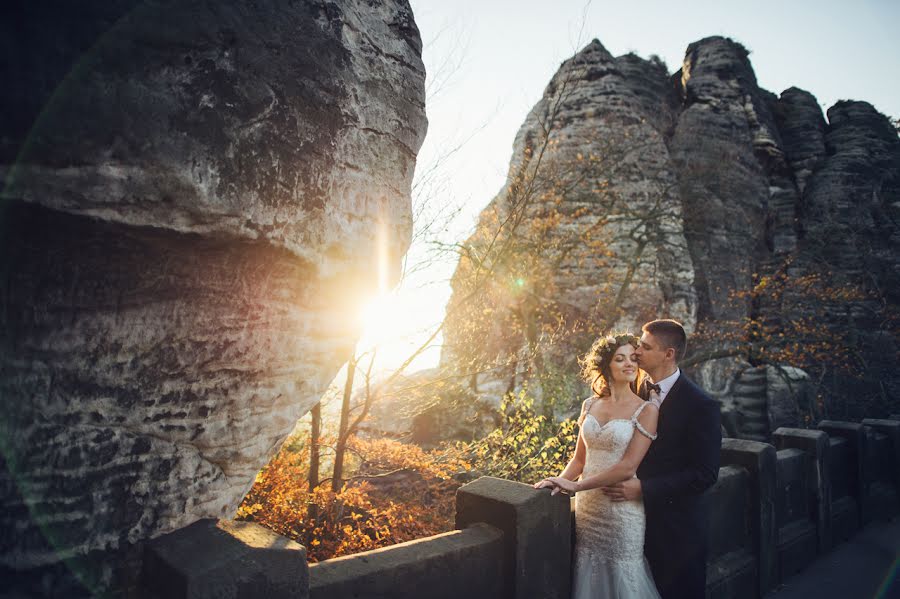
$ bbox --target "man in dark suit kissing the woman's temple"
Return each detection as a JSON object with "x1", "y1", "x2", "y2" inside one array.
[{"x1": 603, "y1": 320, "x2": 722, "y2": 599}]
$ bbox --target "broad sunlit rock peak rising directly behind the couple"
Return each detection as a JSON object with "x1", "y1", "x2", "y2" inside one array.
[{"x1": 442, "y1": 40, "x2": 697, "y2": 396}]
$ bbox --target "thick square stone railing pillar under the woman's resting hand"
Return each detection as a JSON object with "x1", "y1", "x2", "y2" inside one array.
[{"x1": 456, "y1": 476, "x2": 573, "y2": 599}]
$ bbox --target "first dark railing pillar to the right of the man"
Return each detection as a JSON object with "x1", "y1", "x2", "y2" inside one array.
[{"x1": 722, "y1": 439, "x2": 778, "y2": 597}]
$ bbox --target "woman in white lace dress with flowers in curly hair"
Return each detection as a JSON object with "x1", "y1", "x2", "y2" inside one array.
[{"x1": 534, "y1": 335, "x2": 659, "y2": 599}]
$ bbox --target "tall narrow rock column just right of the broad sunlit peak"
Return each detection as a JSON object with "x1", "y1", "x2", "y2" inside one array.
[{"x1": 669, "y1": 38, "x2": 779, "y2": 320}]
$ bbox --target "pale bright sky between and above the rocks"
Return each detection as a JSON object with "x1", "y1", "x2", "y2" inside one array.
[{"x1": 352, "y1": 0, "x2": 900, "y2": 378}]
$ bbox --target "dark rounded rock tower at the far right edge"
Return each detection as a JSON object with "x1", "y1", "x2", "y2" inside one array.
[{"x1": 785, "y1": 101, "x2": 900, "y2": 418}]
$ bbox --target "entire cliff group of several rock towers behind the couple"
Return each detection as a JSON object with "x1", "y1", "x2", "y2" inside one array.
[{"x1": 443, "y1": 37, "x2": 900, "y2": 439}]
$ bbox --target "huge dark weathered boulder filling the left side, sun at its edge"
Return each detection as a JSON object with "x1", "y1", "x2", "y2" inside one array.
[{"x1": 0, "y1": 0, "x2": 426, "y2": 593}]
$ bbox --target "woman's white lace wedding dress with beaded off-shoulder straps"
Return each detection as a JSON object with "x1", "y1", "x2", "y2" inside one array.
[{"x1": 572, "y1": 399, "x2": 659, "y2": 599}]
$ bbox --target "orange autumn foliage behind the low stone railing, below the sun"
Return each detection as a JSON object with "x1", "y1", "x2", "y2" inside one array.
[{"x1": 236, "y1": 438, "x2": 468, "y2": 562}]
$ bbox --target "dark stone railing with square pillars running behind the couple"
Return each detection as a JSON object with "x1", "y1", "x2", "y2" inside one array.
[{"x1": 142, "y1": 420, "x2": 900, "y2": 599}]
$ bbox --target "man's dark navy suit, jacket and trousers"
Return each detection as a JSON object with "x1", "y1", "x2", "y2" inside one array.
[{"x1": 638, "y1": 373, "x2": 722, "y2": 599}]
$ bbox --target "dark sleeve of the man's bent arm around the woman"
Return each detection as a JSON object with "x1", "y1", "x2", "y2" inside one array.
[{"x1": 641, "y1": 398, "x2": 722, "y2": 500}]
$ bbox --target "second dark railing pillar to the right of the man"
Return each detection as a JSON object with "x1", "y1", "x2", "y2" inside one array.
[{"x1": 772, "y1": 427, "x2": 831, "y2": 554}]
